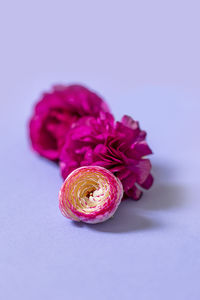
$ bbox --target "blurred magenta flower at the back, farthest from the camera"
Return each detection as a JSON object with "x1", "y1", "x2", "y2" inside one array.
[{"x1": 29, "y1": 85, "x2": 109, "y2": 160}]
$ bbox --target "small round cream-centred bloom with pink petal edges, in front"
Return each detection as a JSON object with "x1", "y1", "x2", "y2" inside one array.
[{"x1": 59, "y1": 166, "x2": 123, "y2": 223}]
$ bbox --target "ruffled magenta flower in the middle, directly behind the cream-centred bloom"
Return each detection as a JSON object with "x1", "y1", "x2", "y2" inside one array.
[{"x1": 60, "y1": 113, "x2": 153, "y2": 200}]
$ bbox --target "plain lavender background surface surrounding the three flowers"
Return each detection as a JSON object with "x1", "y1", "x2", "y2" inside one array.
[{"x1": 0, "y1": 0, "x2": 200, "y2": 300}]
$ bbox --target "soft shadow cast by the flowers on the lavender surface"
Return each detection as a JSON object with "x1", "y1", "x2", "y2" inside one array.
[{"x1": 74, "y1": 184, "x2": 186, "y2": 233}]
